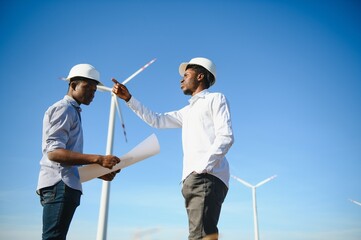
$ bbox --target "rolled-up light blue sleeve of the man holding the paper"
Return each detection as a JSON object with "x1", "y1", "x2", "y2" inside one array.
[{"x1": 44, "y1": 106, "x2": 74, "y2": 152}]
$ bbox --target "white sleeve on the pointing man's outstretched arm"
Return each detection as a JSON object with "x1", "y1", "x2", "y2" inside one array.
[{"x1": 127, "y1": 96, "x2": 182, "y2": 128}]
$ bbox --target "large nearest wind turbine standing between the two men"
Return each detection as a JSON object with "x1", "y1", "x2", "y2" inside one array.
[{"x1": 97, "y1": 59, "x2": 156, "y2": 240}]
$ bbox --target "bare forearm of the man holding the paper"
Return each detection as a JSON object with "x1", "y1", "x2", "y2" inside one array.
[{"x1": 48, "y1": 149, "x2": 101, "y2": 165}]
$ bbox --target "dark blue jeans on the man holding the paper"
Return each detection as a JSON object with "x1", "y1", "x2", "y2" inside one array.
[{"x1": 38, "y1": 181, "x2": 81, "y2": 240}]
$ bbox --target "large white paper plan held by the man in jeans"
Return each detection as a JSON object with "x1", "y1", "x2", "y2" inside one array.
[{"x1": 79, "y1": 134, "x2": 160, "y2": 183}]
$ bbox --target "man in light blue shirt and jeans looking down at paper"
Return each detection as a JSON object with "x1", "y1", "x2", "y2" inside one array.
[{"x1": 37, "y1": 64, "x2": 120, "y2": 240}]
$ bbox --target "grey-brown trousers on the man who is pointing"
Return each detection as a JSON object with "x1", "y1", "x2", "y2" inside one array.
[{"x1": 182, "y1": 173, "x2": 228, "y2": 240}]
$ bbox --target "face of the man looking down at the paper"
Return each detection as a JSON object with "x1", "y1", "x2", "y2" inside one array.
[{"x1": 73, "y1": 80, "x2": 97, "y2": 105}]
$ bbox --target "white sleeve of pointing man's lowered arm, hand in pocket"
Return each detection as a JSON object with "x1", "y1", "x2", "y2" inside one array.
[{"x1": 197, "y1": 94, "x2": 234, "y2": 173}]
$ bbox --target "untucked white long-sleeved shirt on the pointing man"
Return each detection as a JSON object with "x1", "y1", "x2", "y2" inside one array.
[{"x1": 127, "y1": 90, "x2": 234, "y2": 187}]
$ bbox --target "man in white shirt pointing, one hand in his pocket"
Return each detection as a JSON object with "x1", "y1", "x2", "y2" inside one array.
[{"x1": 113, "y1": 58, "x2": 233, "y2": 240}]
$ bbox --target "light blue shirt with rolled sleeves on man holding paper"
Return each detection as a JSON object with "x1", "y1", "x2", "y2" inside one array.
[{"x1": 37, "y1": 95, "x2": 83, "y2": 191}]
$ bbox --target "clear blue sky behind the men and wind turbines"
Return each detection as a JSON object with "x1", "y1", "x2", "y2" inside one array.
[{"x1": 0, "y1": 0, "x2": 361, "y2": 240}]
